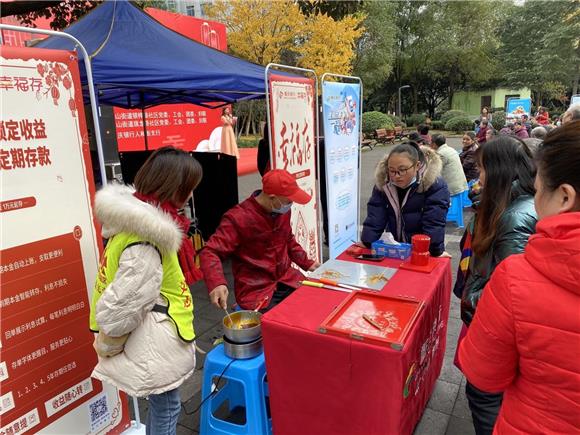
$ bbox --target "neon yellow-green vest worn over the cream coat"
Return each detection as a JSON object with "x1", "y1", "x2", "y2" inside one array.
[{"x1": 90, "y1": 233, "x2": 195, "y2": 342}]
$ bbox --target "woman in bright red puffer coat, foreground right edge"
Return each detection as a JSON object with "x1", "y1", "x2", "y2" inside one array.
[{"x1": 459, "y1": 121, "x2": 580, "y2": 434}]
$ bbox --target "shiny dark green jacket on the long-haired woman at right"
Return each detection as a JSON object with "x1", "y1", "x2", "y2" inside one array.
[{"x1": 461, "y1": 194, "x2": 537, "y2": 325}]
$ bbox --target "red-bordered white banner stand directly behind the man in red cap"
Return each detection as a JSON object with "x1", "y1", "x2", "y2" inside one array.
[{"x1": 265, "y1": 63, "x2": 322, "y2": 263}]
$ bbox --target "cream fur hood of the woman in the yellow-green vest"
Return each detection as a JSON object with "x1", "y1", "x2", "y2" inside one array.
[{"x1": 95, "y1": 184, "x2": 183, "y2": 253}]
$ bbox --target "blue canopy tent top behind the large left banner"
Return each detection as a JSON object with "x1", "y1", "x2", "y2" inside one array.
[{"x1": 35, "y1": 0, "x2": 265, "y2": 109}]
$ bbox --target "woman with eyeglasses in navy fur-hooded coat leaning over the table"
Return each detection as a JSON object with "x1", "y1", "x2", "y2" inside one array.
[{"x1": 361, "y1": 141, "x2": 449, "y2": 257}]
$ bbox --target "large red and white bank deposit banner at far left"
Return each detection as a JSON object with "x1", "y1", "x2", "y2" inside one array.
[{"x1": 0, "y1": 47, "x2": 129, "y2": 434}]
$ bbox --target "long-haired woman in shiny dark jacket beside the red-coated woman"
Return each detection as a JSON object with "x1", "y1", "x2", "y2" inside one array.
[{"x1": 454, "y1": 135, "x2": 537, "y2": 435}]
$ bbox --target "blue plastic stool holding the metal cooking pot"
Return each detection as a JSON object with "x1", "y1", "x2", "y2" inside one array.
[{"x1": 199, "y1": 344, "x2": 272, "y2": 435}]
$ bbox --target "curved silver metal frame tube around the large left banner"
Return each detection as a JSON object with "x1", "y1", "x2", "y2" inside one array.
[{"x1": 0, "y1": 24, "x2": 107, "y2": 186}]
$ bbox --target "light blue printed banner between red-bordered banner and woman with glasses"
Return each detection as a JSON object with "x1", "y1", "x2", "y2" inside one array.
[{"x1": 321, "y1": 73, "x2": 362, "y2": 259}]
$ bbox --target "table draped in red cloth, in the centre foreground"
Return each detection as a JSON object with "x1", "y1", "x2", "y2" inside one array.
[{"x1": 262, "y1": 254, "x2": 451, "y2": 435}]
